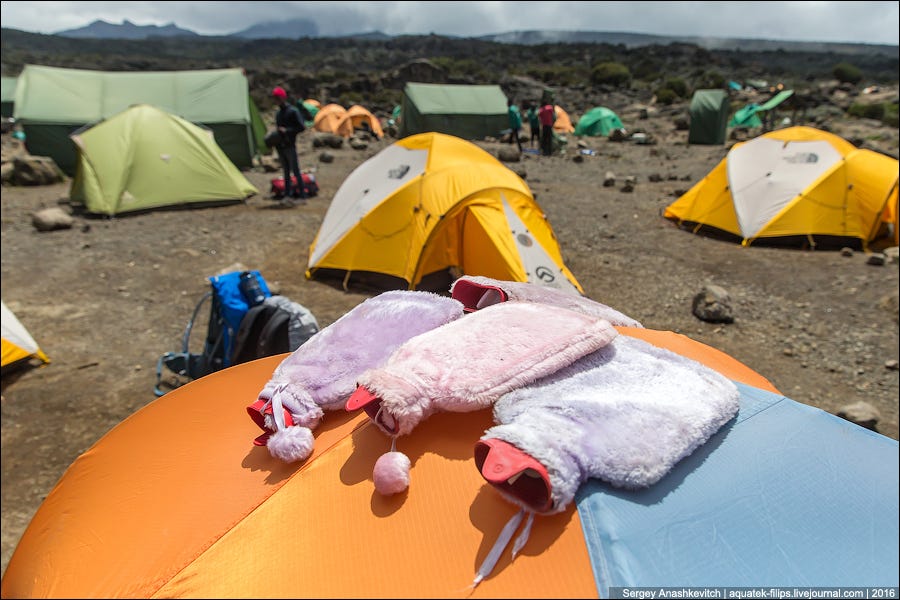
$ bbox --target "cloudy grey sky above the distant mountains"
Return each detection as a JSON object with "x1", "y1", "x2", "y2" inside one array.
[{"x1": 0, "y1": 1, "x2": 900, "y2": 45}]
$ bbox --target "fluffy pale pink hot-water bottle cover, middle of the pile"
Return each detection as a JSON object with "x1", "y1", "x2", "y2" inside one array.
[{"x1": 359, "y1": 302, "x2": 618, "y2": 435}]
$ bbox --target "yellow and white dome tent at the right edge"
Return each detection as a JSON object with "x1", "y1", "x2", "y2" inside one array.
[{"x1": 663, "y1": 127, "x2": 898, "y2": 248}]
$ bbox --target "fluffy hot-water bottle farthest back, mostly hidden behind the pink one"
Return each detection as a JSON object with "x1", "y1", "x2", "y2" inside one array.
[{"x1": 450, "y1": 275, "x2": 643, "y2": 328}]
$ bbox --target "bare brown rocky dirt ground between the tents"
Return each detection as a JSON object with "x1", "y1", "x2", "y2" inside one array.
[{"x1": 0, "y1": 96, "x2": 898, "y2": 571}]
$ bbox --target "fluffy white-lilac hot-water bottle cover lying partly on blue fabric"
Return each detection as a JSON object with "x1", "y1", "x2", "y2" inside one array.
[{"x1": 482, "y1": 336, "x2": 739, "y2": 513}]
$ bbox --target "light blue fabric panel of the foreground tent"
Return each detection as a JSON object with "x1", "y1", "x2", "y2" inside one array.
[{"x1": 576, "y1": 383, "x2": 898, "y2": 598}]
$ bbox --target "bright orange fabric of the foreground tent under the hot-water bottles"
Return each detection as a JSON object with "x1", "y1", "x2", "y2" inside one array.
[{"x1": 2, "y1": 327, "x2": 777, "y2": 598}]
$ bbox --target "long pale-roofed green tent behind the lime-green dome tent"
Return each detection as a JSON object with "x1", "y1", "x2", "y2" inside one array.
[{"x1": 14, "y1": 65, "x2": 267, "y2": 175}]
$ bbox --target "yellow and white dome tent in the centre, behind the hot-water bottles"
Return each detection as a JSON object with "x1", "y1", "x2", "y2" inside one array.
[{"x1": 306, "y1": 132, "x2": 583, "y2": 294}]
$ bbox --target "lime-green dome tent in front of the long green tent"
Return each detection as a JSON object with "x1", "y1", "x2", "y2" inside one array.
[{"x1": 69, "y1": 104, "x2": 257, "y2": 215}]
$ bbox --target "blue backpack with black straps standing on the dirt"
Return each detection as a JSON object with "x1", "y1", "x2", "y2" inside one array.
[{"x1": 153, "y1": 270, "x2": 272, "y2": 396}]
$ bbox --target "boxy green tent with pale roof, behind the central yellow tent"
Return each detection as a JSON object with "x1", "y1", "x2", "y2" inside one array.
[{"x1": 399, "y1": 83, "x2": 509, "y2": 140}]
